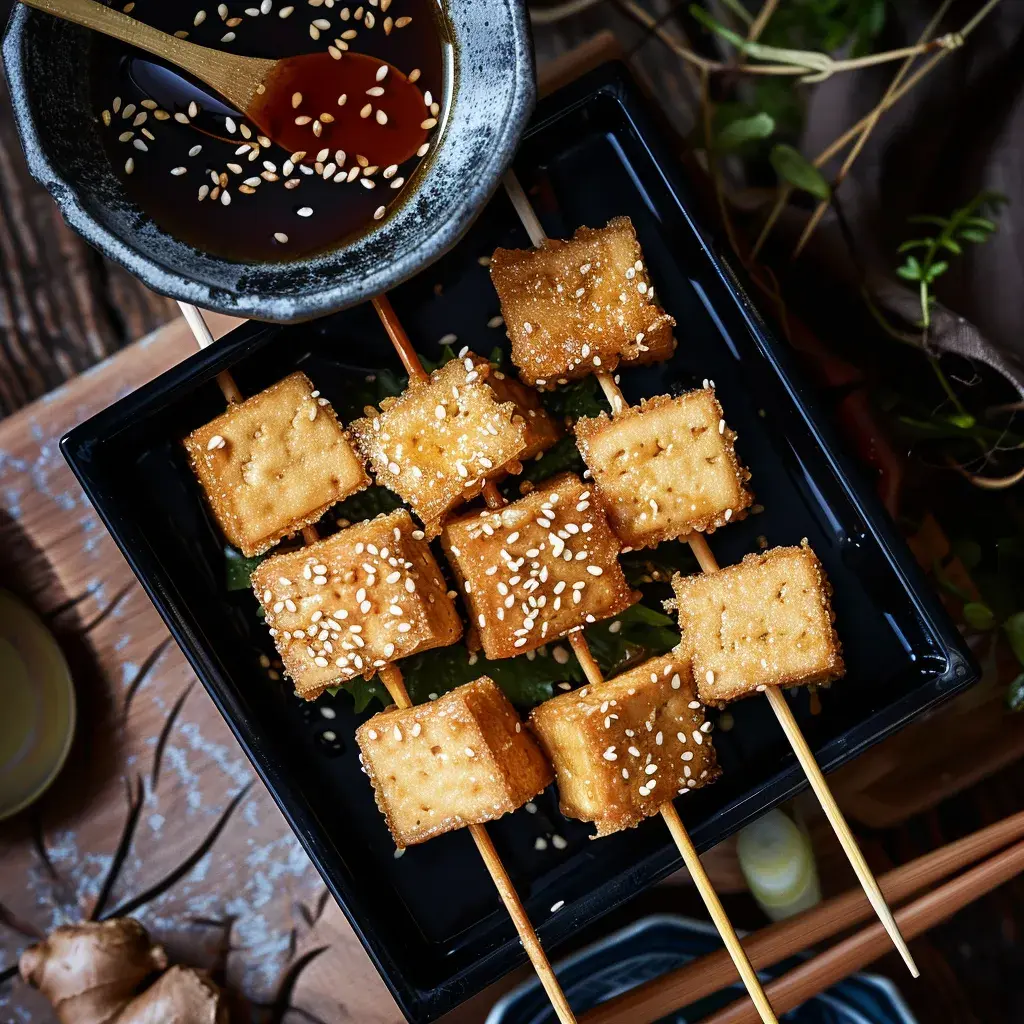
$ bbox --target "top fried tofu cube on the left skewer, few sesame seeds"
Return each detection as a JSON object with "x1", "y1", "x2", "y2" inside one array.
[{"x1": 184, "y1": 373, "x2": 370, "y2": 557}]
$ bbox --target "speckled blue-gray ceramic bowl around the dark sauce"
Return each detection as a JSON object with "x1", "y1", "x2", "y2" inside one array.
[{"x1": 3, "y1": 0, "x2": 536, "y2": 322}]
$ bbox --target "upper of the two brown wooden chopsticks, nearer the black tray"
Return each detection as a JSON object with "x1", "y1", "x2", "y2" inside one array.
[{"x1": 580, "y1": 811, "x2": 1024, "y2": 1024}]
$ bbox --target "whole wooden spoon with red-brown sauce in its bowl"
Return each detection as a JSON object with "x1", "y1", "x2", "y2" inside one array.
[{"x1": 24, "y1": 0, "x2": 428, "y2": 167}]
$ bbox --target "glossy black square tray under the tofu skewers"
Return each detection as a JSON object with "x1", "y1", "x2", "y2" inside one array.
[{"x1": 61, "y1": 66, "x2": 975, "y2": 1021}]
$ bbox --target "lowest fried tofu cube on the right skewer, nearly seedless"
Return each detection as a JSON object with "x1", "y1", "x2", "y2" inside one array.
[{"x1": 672, "y1": 540, "x2": 845, "y2": 707}]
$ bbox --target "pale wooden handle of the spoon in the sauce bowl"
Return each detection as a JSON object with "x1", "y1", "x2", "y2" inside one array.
[{"x1": 23, "y1": 0, "x2": 276, "y2": 113}]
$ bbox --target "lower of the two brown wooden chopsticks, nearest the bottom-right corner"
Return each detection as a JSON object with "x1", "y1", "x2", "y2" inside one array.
[{"x1": 700, "y1": 843, "x2": 1024, "y2": 1024}]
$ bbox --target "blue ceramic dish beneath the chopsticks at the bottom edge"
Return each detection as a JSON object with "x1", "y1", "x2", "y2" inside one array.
[{"x1": 485, "y1": 914, "x2": 916, "y2": 1024}]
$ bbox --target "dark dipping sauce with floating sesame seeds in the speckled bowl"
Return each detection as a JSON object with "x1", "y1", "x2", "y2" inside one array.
[{"x1": 92, "y1": 0, "x2": 451, "y2": 263}]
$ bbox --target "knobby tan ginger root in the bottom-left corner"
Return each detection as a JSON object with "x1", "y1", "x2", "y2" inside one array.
[{"x1": 18, "y1": 918, "x2": 227, "y2": 1024}]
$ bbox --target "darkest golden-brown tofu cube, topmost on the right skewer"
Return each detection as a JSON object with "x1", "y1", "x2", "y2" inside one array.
[{"x1": 490, "y1": 217, "x2": 676, "y2": 388}]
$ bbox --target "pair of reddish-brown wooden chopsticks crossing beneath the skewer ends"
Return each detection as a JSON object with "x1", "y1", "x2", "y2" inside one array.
[{"x1": 580, "y1": 812, "x2": 1024, "y2": 1024}]
